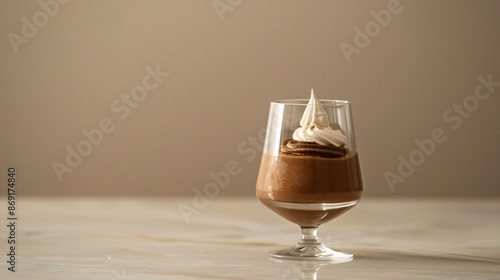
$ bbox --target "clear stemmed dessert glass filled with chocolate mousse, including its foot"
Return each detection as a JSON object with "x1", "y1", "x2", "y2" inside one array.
[{"x1": 256, "y1": 93, "x2": 363, "y2": 261}]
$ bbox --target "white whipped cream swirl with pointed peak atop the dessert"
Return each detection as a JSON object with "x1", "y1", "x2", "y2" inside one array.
[{"x1": 293, "y1": 89, "x2": 347, "y2": 147}]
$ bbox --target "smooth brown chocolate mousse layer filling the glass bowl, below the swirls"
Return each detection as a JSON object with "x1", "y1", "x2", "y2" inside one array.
[{"x1": 257, "y1": 145, "x2": 363, "y2": 226}]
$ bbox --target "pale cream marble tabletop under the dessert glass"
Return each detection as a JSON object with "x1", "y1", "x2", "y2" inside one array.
[{"x1": 0, "y1": 197, "x2": 500, "y2": 280}]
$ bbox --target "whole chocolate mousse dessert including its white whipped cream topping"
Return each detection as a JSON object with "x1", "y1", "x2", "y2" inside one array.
[{"x1": 256, "y1": 91, "x2": 363, "y2": 227}]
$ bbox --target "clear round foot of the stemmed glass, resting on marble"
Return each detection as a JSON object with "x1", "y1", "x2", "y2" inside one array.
[{"x1": 269, "y1": 244, "x2": 353, "y2": 263}]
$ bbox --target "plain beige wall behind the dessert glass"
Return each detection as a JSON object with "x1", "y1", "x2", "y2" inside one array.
[{"x1": 0, "y1": 0, "x2": 500, "y2": 196}]
